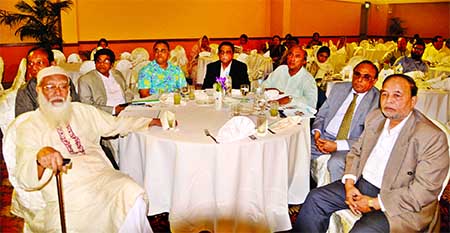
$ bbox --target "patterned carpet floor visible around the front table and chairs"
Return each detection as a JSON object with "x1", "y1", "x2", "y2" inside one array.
[{"x1": 0, "y1": 128, "x2": 450, "y2": 233}]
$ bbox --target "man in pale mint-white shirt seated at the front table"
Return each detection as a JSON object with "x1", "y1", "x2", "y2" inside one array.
[{"x1": 263, "y1": 46, "x2": 317, "y2": 109}]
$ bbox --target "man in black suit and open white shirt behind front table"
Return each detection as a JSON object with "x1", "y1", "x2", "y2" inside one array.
[{"x1": 202, "y1": 41, "x2": 250, "y2": 89}]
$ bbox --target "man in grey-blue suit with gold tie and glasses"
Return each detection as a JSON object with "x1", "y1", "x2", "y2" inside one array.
[{"x1": 311, "y1": 61, "x2": 379, "y2": 181}]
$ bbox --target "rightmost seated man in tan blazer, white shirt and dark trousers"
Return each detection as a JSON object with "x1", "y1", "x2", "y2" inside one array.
[{"x1": 294, "y1": 74, "x2": 449, "y2": 232}]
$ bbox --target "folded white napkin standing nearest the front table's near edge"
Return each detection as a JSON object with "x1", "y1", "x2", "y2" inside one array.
[{"x1": 217, "y1": 116, "x2": 256, "y2": 143}]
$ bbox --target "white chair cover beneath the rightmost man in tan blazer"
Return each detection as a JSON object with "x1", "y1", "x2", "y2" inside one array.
[{"x1": 327, "y1": 118, "x2": 450, "y2": 233}]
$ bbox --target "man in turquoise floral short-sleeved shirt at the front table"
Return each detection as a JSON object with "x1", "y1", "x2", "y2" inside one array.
[{"x1": 138, "y1": 40, "x2": 187, "y2": 97}]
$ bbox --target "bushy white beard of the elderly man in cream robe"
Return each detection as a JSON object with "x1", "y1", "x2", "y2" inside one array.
[{"x1": 38, "y1": 92, "x2": 72, "y2": 129}]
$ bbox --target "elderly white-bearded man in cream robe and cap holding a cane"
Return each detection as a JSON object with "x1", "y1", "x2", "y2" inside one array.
[{"x1": 6, "y1": 66, "x2": 160, "y2": 232}]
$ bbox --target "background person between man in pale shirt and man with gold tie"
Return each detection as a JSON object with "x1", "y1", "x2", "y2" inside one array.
[{"x1": 306, "y1": 46, "x2": 334, "y2": 79}]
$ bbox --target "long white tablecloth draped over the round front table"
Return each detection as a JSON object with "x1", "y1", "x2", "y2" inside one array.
[{"x1": 119, "y1": 103, "x2": 310, "y2": 232}]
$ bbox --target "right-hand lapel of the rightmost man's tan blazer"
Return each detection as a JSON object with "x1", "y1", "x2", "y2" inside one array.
[{"x1": 381, "y1": 112, "x2": 416, "y2": 188}]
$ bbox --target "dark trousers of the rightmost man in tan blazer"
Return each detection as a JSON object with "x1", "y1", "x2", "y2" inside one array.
[{"x1": 293, "y1": 178, "x2": 389, "y2": 233}]
